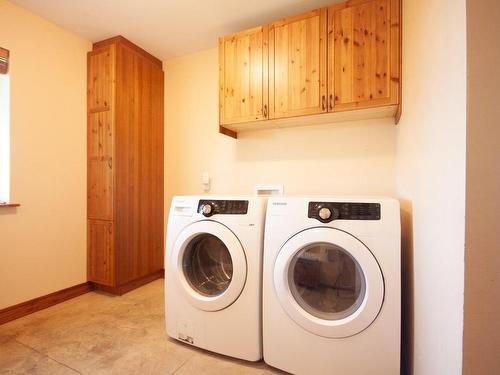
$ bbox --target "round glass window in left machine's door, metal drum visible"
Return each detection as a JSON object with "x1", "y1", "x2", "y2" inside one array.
[{"x1": 182, "y1": 233, "x2": 233, "y2": 297}]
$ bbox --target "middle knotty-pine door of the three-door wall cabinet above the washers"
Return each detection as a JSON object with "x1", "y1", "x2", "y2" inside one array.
[{"x1": 269, "y1": 9, "x2": 327, "y2": 118}]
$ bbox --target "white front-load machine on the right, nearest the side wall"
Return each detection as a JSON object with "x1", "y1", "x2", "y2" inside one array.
[{"x1": 263, "y1": 198, "x2": 401, "y2": 375}]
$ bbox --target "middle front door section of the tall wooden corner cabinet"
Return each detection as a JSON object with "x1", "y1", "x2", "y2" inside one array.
[{"x1": 87, "y1": 111, "x2": 113, "y2": 220}]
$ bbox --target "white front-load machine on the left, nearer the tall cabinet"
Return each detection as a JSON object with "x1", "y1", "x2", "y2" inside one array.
[{"x1": 165, "y1": 196, "x2": 266, "y2": 361}]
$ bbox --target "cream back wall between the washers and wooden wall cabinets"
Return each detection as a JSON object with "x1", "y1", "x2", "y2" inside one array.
[{"x1": 164, "y1": 49, "x2": 396, "y2": 207}]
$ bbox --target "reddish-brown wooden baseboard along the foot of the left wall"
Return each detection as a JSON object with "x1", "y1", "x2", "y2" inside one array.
[{"x1": 0, "y1": 282, "x2": 93, "y2": 324}]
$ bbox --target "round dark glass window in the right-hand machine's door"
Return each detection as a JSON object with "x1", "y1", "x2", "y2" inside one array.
[{"x1": 288, "y1": 243, "x2": 366, "y2": 320}]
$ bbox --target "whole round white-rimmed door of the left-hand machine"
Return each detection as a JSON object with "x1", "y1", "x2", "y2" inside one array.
[{"x1": 170, "y1": 220, "x2": 247, "y2": 311}]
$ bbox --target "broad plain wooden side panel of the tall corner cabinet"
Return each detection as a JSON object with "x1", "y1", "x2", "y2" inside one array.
[{"x1": 115, "y1": 45, "x2": 163, "y2": 284}]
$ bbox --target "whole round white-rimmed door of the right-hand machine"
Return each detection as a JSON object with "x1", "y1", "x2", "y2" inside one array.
[{"x1": 274, "y1": 227, "x2": 384, "y2": 338}]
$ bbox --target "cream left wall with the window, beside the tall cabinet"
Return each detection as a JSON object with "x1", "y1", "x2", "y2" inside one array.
[{"x1": 0, "y1": 0, "x2": 91, "y2": 309}]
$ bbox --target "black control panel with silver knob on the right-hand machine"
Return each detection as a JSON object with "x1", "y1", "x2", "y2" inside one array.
[{"x1": 307, "y1": 202, "x2": 380, "y2": 223}]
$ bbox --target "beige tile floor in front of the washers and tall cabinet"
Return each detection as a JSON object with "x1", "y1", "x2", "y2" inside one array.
[{"x1": 0, "y1": 280, "x2": 280, "y2": 375}]
